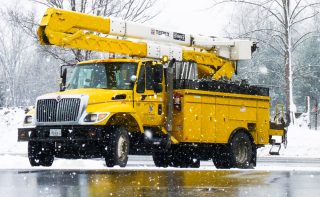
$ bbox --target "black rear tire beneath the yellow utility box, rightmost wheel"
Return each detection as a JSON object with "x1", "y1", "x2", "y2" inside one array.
[{"x1": 230, "y1": 131, "x2": 253, "y2": 169}]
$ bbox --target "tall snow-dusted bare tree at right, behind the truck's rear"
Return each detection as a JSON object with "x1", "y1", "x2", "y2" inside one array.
[{"x1": 211, "y1": 0, "x2": 320, "y2": 124}]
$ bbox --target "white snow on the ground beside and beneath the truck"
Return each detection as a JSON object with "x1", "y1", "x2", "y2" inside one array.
[{"x1": 0, "y1": 108, "x2": 320, "y2": 169}]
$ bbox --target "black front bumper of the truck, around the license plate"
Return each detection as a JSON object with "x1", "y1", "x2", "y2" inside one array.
[{"x1": 18, "y1": 125, "x2": 106, "y2": 142}]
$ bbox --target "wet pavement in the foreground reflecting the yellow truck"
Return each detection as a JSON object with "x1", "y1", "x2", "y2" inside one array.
[{"x1": 0, "y1": 168, "x2": 320, "y2": 197}]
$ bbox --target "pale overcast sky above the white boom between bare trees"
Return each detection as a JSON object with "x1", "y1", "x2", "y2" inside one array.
[{"x1": 0, "y1": 0, "x2": 232, "y2": 36}]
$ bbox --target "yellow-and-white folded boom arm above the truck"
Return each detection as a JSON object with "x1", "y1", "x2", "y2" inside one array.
[{"x1": 38, "y1": 8, "x2": 253, "y2": 79}]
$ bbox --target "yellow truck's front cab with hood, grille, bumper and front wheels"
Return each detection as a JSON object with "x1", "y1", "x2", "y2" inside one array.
[{"x1": 18, "y1": 59, "x2": 166, "y2": 166}]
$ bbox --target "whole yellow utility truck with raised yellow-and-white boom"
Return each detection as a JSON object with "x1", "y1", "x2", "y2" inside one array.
[{"x1": 18, "y1": 8, "x2": 286, "y2": 168}]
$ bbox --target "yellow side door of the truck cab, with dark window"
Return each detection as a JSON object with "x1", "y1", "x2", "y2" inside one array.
[{"x1": 134, "y1": 61, "x2": 165, "y2": 126}]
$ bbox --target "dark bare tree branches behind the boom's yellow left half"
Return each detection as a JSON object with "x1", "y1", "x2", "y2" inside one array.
[{"x1": 25, "y1": 0, "x2": 160, "y2": 63}]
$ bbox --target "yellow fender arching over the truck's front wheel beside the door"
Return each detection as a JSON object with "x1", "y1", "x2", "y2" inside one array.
[{"x1": 86, "y1": 103, "x2": 144, "y2": 133}]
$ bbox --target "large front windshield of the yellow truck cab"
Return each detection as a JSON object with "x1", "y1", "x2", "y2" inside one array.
[{"x1": 67, "y1": 62, "x2": 138, "y2": 90}]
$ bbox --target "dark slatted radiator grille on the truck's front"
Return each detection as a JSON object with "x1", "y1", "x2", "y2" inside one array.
[{"x1": 37, "y1": 98, "x2": 80, "y2": 122}]
